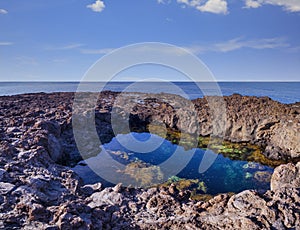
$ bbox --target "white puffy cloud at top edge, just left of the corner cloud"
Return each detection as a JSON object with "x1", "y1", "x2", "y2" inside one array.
[{"x1": 177, "y1": 0, "x2": 228, "y2": 14}]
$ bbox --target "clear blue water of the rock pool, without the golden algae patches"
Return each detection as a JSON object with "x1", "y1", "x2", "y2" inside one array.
[{"x1": 74, "y1": 133, "x2": 273, "y2": 194}]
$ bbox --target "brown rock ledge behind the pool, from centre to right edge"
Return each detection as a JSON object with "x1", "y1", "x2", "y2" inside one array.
[{"x1": 76, "y1": 93, "x2": 300, "y2": 161}]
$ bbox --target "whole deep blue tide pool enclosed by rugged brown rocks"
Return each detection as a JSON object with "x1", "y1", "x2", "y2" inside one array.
[{"x1": 73, "y1": 133, "x2": 273, "y2": 194}]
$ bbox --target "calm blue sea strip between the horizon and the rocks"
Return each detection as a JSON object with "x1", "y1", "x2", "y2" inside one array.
[{"x1": 0, "y1": 82, "x2": 300, "y2": 103}]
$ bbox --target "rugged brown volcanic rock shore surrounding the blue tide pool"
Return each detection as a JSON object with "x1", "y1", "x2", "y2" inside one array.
[{"x1": 0, "y1": 91, "x2": 300, "y2": 229}]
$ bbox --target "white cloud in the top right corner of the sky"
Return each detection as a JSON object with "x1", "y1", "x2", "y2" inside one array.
[{"x1": 245, "y1": 0, "x2": 300, "y2": 12}]
